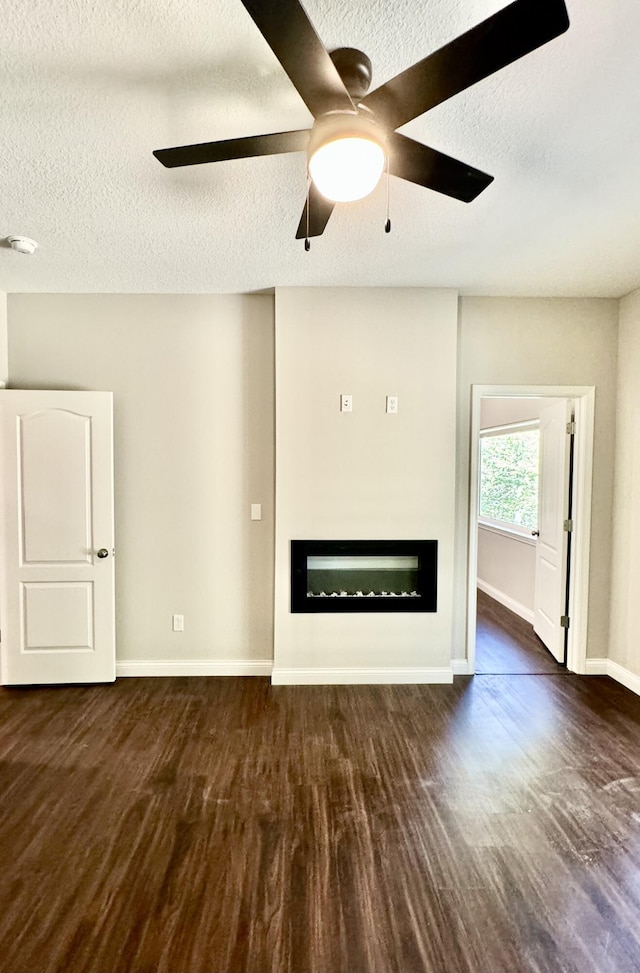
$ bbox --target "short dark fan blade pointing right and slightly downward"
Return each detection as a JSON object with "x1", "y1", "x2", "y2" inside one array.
[{"x1": 388, "y1": 132, "x2": 493, "y2": 203}]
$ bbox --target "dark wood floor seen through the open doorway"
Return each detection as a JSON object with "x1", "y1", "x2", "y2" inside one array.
[{"x1": 475, "y1": 589, "x2": 567, "y2": 675}]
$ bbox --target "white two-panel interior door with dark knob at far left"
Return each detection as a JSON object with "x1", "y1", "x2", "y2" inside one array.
[{"x1": 0, "y1": 390, "x2": 115, "y2": 685}]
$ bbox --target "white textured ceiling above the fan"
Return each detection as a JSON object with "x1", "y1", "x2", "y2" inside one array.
[{"x1": 0, "y1": 0, "x2": 640, "y2": 297}]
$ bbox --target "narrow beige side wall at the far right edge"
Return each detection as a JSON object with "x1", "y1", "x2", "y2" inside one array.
[{"x1": 603, "y1": 290, "x2": 640, "y2": 675}]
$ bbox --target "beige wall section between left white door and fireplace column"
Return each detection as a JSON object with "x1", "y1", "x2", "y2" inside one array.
[{"x1": 9, "y1": 294, "x2": 273, "y2": 660}]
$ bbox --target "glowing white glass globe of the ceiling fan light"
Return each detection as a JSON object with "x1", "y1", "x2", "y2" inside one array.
[{"x1": 309, "y1": 136, "x2": 385, "y2": 203}]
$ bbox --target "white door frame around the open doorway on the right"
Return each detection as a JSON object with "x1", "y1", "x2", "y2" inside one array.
[{"x1": 466, "y1": 385, "x2": 596, "y2": 675}]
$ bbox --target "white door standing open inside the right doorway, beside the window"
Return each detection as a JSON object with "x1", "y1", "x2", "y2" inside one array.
[{"x1": 533, "y1": 399, "x2": 572, "y2": 662}]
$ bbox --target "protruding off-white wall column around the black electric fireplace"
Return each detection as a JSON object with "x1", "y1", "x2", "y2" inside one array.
[{"x1": 274, "y1": 288, "x2": 457, "y2": 682}]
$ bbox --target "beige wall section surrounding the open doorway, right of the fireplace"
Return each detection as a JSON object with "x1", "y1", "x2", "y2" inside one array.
[{"x1": 453, "y1": 297, "x2": 618, "y2": 658}]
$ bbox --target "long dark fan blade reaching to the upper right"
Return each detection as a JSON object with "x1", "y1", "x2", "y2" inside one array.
[{"x1": 363, "y1": 0, "x2": 569, "y2": 128}]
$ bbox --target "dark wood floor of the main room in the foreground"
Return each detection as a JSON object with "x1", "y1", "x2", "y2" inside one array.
[{"x1": 0, "y1": 674, "x2": 640, "y2": 973}]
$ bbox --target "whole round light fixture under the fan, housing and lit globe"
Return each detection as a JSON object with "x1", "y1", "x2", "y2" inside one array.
[{"x1": 308, "y1": 112, "x2": 387, "y2": 203}]
